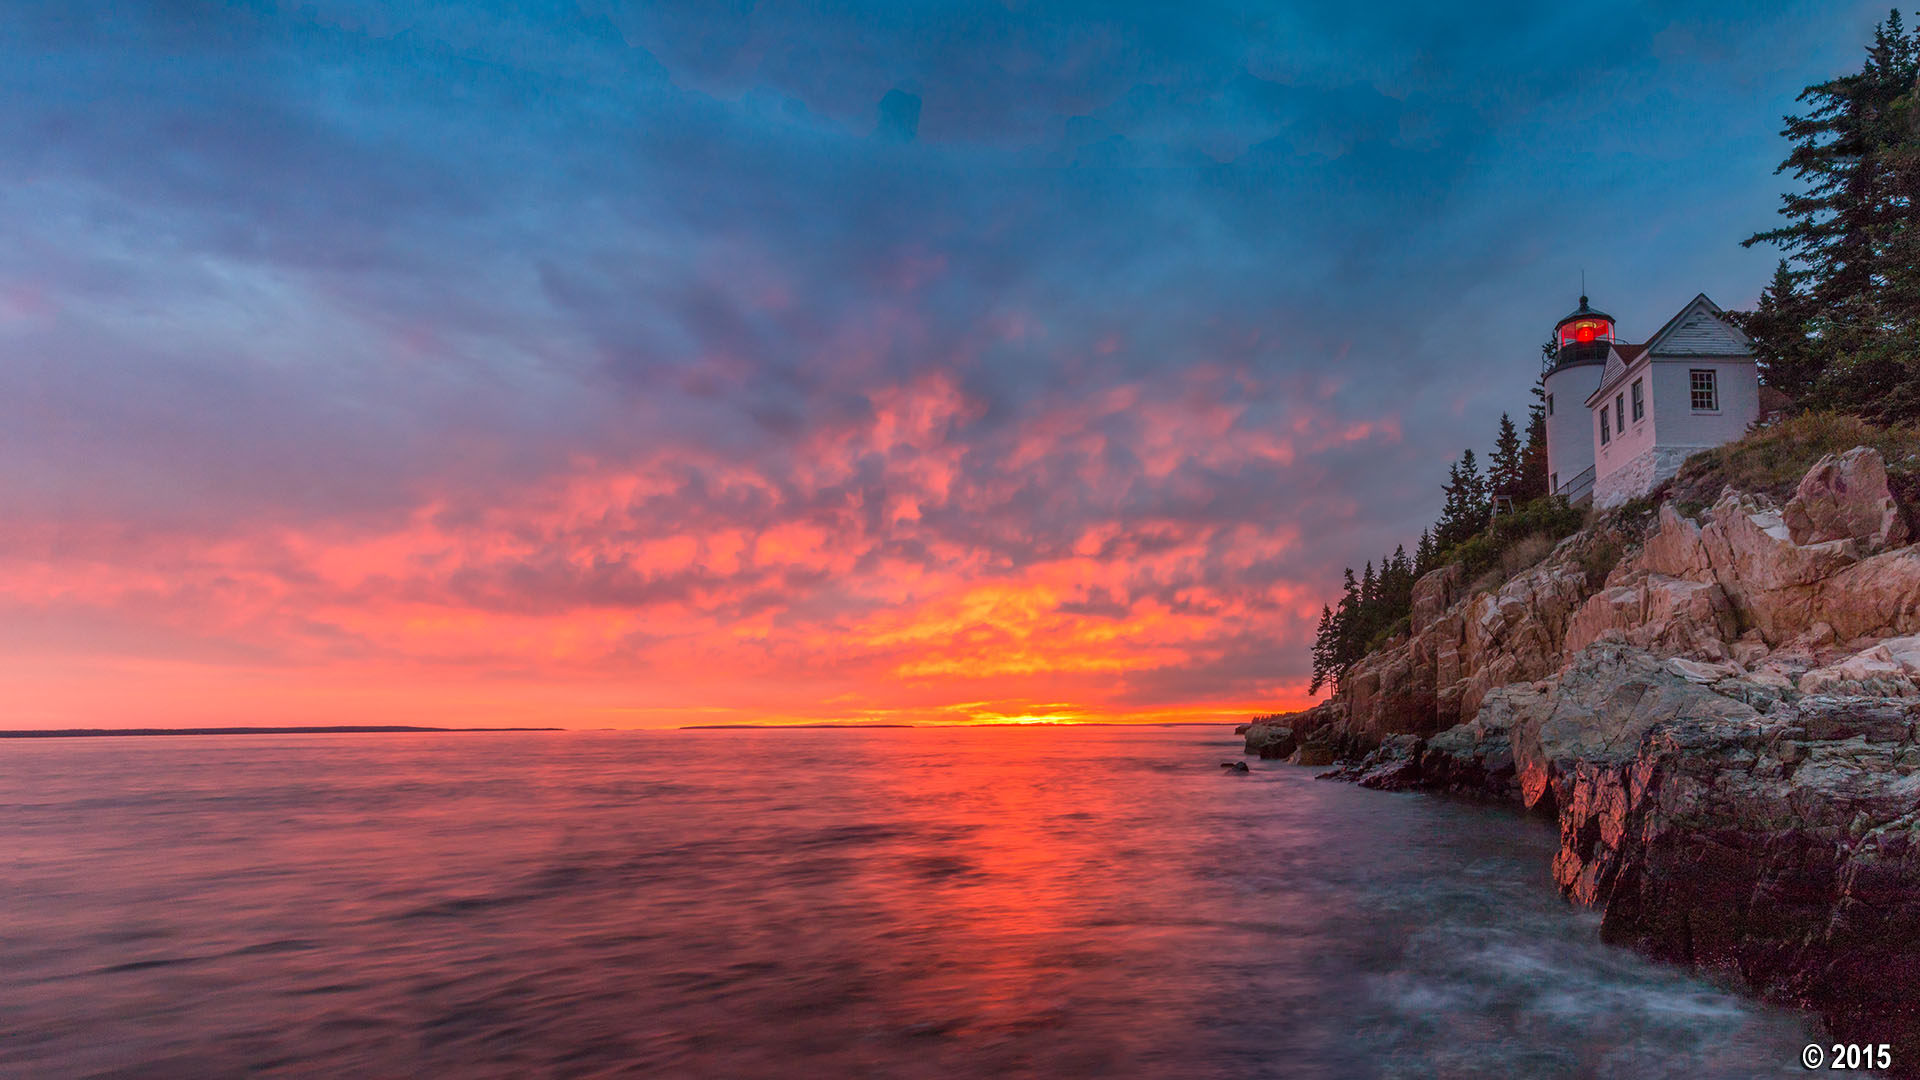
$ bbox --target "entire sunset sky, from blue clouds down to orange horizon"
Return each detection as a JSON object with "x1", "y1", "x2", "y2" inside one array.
[{"x1": 0, "y1": 0, "x2": 1885, "y2": 728}]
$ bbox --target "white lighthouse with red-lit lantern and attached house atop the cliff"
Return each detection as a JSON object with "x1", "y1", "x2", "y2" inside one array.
[{"x1": 1542, "y1": 294, "x2": 1761, "y2": 509}]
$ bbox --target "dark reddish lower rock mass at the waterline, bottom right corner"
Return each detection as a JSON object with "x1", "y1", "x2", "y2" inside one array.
[{"x1": 1553, "y1": 698, "x2": 1920, "y2": 1068}]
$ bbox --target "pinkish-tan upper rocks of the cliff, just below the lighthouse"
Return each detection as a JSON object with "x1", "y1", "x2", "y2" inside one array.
[{"x1": 1320, "y1": 448, "x2": 1920, "y2": 773}]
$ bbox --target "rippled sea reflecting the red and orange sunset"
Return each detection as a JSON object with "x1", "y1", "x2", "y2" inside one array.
[{"x1": 0, "y1": 728, "x2": 1814, "y2": 1078}]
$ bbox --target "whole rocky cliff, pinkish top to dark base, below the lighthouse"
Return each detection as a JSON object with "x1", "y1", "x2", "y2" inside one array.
[{"x1": 1246, "y1": 448, "x2": 1920, "y2": 1074}]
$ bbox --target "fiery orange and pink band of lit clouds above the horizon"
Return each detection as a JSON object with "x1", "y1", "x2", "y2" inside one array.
[{"x1": 0, "y1": 365, "x2": 1374, "y2": 728}]
